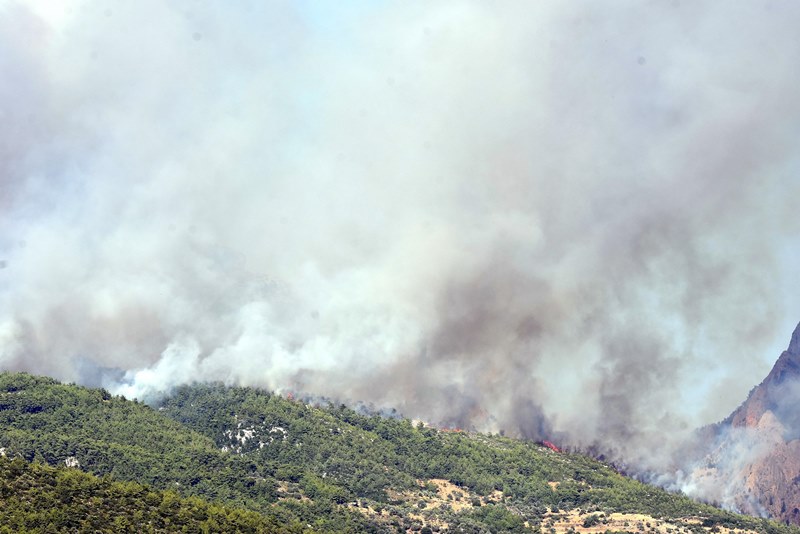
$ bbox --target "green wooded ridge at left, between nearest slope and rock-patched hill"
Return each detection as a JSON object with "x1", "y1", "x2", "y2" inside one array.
[{"x1": 0, "y1": 373, "x2": 370, "y2": 532}]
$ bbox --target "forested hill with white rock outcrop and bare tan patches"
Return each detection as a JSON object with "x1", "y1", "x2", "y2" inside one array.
[{"x1": 160, "y1": 385, "x2": 800, "y2": 532}]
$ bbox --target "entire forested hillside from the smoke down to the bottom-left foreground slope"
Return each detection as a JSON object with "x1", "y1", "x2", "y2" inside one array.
[{"x1": 0, "y1": 373, "x2": 797, "y2": 533}]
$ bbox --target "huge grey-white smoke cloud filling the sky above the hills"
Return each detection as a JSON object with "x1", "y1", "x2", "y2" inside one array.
[{"x1": 0, "y1": 0, "x2": 800, "y2": 478}]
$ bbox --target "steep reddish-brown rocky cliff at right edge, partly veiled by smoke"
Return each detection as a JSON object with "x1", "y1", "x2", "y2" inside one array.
[{"x1": 691, "y1": 325, "x2": 800, "y2": 524}]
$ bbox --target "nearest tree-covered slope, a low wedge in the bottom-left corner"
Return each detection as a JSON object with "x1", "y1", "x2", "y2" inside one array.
[{"x1": 0, "y1": 457, "x2": 286, "y2": 534}]
